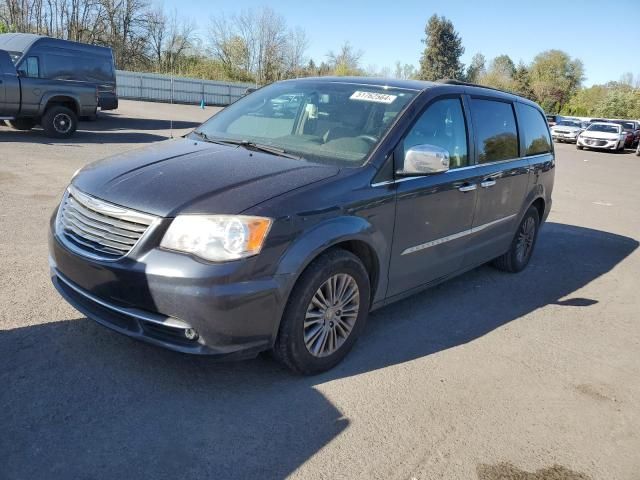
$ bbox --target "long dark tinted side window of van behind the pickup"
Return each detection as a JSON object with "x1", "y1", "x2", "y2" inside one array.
[{"x1": 41, "y1": 52, "x2": 114, "y2": 83}]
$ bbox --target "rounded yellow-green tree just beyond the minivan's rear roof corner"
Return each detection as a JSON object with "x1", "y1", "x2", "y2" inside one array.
[{"x1": 529, "y1": 50, "x2": 584, "y2": 113}]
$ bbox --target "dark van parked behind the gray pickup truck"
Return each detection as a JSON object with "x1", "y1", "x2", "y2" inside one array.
[{"x1": 0, "y1": 33, "x2": 118, "y2": 110}]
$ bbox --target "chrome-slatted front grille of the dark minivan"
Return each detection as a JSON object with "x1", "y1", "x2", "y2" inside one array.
[{"x1": 56, "y1": 186, "x2": 156, "y2": 260}]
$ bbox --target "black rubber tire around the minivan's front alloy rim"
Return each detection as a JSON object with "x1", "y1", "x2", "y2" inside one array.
[{"x1": 273, "y1": 248, "x2": 371, "y2": 375}]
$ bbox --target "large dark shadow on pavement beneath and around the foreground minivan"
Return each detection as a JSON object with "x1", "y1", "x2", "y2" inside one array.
[{"x1": 0, "y1": 223, "x2": 638, "y2": 480}]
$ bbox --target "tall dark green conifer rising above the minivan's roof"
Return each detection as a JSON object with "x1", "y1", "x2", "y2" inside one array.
[{"x1": 420, "y1": 15, "x2": 464, "y2": 80}]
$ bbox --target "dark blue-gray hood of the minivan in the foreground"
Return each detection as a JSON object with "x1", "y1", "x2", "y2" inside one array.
[{"x1": 73, "y1": 139, "x2": 339, "y2": 217}]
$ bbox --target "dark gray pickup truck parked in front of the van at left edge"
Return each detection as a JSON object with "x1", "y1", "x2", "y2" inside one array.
[{"x1": 0, "y1": 50, "x2": 98, "y2": 138}]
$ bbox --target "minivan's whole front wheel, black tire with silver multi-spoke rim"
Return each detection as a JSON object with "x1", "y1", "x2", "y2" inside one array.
[{"x1": 273, "y1": 248, "x2": 371, "y2": 375}]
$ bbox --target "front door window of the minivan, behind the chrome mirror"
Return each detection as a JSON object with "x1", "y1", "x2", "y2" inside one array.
[{"x1": 403, "y1": 98, "x2": 469, "y2": 169}]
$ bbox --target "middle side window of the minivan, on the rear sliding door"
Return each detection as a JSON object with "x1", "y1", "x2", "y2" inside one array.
[{"x1": 471, "y1": 98, "x2": 518, "y2": 163}]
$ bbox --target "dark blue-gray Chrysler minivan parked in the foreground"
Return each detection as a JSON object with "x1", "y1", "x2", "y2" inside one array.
[{"x1": 49, "y1": 77, "x2": 555, "y2": 374}]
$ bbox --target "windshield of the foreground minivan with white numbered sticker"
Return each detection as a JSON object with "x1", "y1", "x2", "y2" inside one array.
[{"x1": 195, "y1": 80, "x2": 418, "y2": 166}]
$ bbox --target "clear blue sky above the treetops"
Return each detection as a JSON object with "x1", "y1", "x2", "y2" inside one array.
[{"x1": 171, "y1": 0, "x2": 640, "y2": 86}]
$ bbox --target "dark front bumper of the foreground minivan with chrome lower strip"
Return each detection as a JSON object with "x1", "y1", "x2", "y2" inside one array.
[{"x1": 49, "y1": 224, "x2": 289, "y2": 358}]
